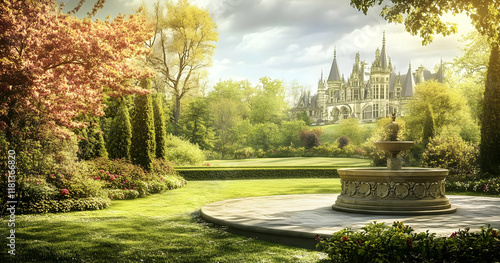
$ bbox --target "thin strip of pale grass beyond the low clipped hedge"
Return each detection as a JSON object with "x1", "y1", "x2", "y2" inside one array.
[{"x1": 200, "y1": 157, "x2": 370, "y2": 167}]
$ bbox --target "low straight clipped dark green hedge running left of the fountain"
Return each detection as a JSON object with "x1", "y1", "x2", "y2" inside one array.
[{"x1": 176, "y1": 167, "x2": 339, "y2": 181}]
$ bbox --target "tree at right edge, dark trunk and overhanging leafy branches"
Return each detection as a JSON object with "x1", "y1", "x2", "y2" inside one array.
[{"x1": 351, "y1": 0, "x2": 500, "y2": 174}]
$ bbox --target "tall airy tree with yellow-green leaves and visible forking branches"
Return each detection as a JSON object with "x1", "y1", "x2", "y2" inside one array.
[{"x1": 147, "y1": 0, "x2": 218, "y2": 132}]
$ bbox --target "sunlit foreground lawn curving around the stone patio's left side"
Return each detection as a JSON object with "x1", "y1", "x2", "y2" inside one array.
[{"x1": 0, "y1": 179, "x2": 340, "y2": 262}]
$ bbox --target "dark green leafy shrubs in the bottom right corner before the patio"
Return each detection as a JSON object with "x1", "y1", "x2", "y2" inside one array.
[{"x1": 317, "y1": 222, "x2": 500, "y2": 262}]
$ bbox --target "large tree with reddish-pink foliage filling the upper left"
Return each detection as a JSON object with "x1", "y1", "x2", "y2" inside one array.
[{"x1": 0, "y1": 0, "x2": 153, "y2": 139}]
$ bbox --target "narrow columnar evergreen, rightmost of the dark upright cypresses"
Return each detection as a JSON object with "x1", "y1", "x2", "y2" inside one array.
[{"x1": 153, "y1": 93, "x2": 167, "y2": 159}]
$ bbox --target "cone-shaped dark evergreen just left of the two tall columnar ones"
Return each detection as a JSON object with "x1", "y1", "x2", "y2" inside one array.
[{"x1": 107, "y1": 99, "x2": 132, "y2": 159}]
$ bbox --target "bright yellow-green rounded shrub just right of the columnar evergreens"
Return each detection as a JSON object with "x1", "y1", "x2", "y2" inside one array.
[{"x1": 167, "y1": 135, "x2": 205, "y2": 165}]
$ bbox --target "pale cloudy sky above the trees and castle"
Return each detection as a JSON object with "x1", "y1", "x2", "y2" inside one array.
[{"x1": 59, "y1": 0, "x2": 473, "y2": 91}]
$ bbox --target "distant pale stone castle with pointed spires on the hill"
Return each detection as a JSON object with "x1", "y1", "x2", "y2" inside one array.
[{"x1": 291, "y1": 32, "x2": 444, "y2": 124}]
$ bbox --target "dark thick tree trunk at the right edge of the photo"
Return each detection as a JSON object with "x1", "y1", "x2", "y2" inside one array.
[{"x1": 480, "y1": 44, "x2": 500, "y2": 175}]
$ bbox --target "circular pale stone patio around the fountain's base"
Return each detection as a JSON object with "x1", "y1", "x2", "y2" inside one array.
[{"x1": 201, "y1": 194, "x2": 500, "y2": 251}]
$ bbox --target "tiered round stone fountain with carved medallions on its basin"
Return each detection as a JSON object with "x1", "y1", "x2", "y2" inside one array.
[{"x1": 332, "y1": 114, "x2": 456, "y2": 215}]
